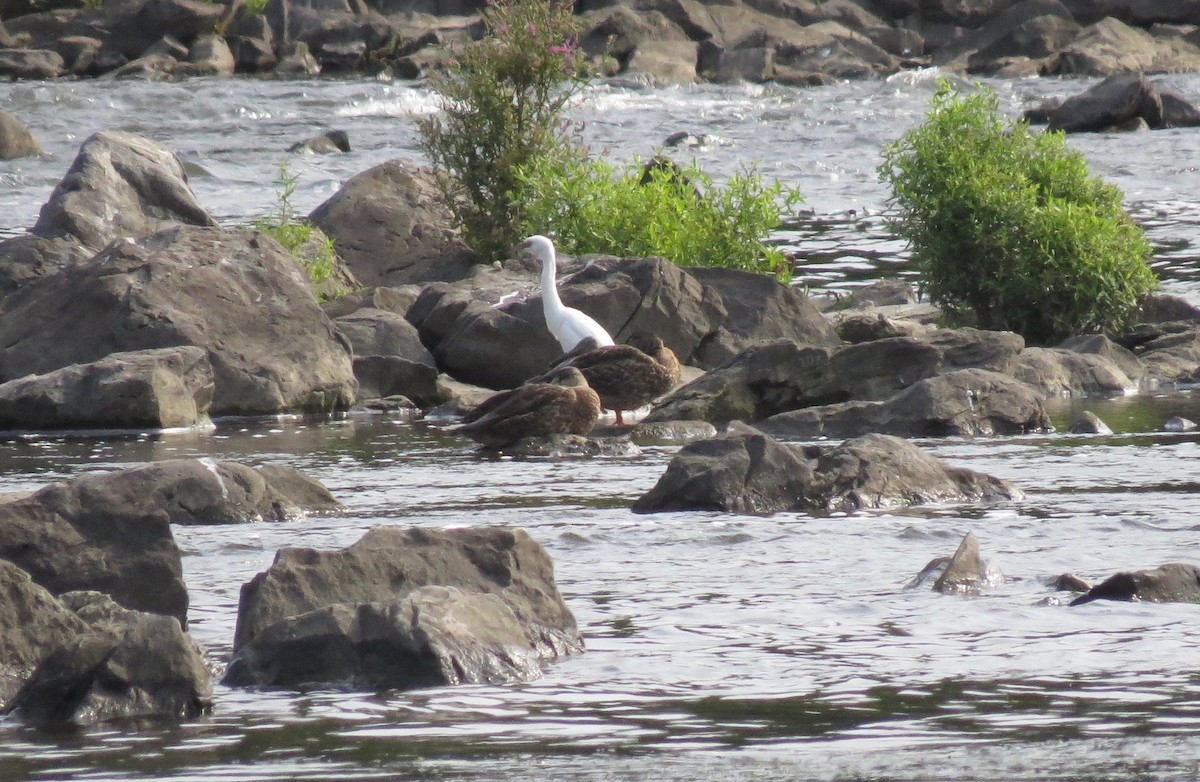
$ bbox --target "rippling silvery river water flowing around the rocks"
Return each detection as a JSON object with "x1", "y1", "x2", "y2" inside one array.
[{"x1": 0, "y1": 73, "x2": 1200, "y2": 781}]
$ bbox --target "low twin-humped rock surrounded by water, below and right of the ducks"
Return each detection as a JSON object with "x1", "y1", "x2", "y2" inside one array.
[{"x1": 632, "y1": 433, "x2": 1020, "y2": 513}]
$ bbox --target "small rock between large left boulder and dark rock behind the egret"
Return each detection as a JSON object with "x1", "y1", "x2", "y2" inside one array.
[{"x1": 334, "y1": 308, "x2": 446, "y2": 407}]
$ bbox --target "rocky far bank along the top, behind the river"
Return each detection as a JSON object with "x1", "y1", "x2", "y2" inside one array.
[{"x1": 0, "y1": 0, "x2": 1200, "y2": 85}]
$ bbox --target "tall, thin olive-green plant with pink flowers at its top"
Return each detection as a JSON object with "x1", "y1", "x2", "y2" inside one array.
[{"x1": 418, "y1": 0, "x2": 583, "y2": 258}]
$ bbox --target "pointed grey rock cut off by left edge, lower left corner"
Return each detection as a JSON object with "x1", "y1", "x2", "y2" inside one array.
[{"x1": 0, "y1": 559, "x2": 88, "y2": 711}]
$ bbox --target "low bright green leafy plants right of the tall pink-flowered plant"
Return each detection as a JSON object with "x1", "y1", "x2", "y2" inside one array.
[{"x1": 518, "y1": 158, "x2": 803, "y2": 282}]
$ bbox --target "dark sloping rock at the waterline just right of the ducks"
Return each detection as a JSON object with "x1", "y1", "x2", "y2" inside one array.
[{"x1": 643, "y1": 339, "x2": 846, "y2": 425}]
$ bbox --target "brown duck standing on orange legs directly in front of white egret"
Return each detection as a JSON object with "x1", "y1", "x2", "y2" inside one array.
[{"x1": 542, "y1": 332, "x2": 679, "y2": 426}]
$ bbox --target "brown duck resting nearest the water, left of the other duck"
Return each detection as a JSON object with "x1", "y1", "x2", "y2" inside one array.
[{"x1": 455, "y1": 367, "x2": 600, "y2": 449}]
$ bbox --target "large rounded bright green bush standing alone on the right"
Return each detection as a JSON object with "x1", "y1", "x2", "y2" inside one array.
[{"x1": 878, "y1": 82, "x2": 1157, "y2": 344}]
